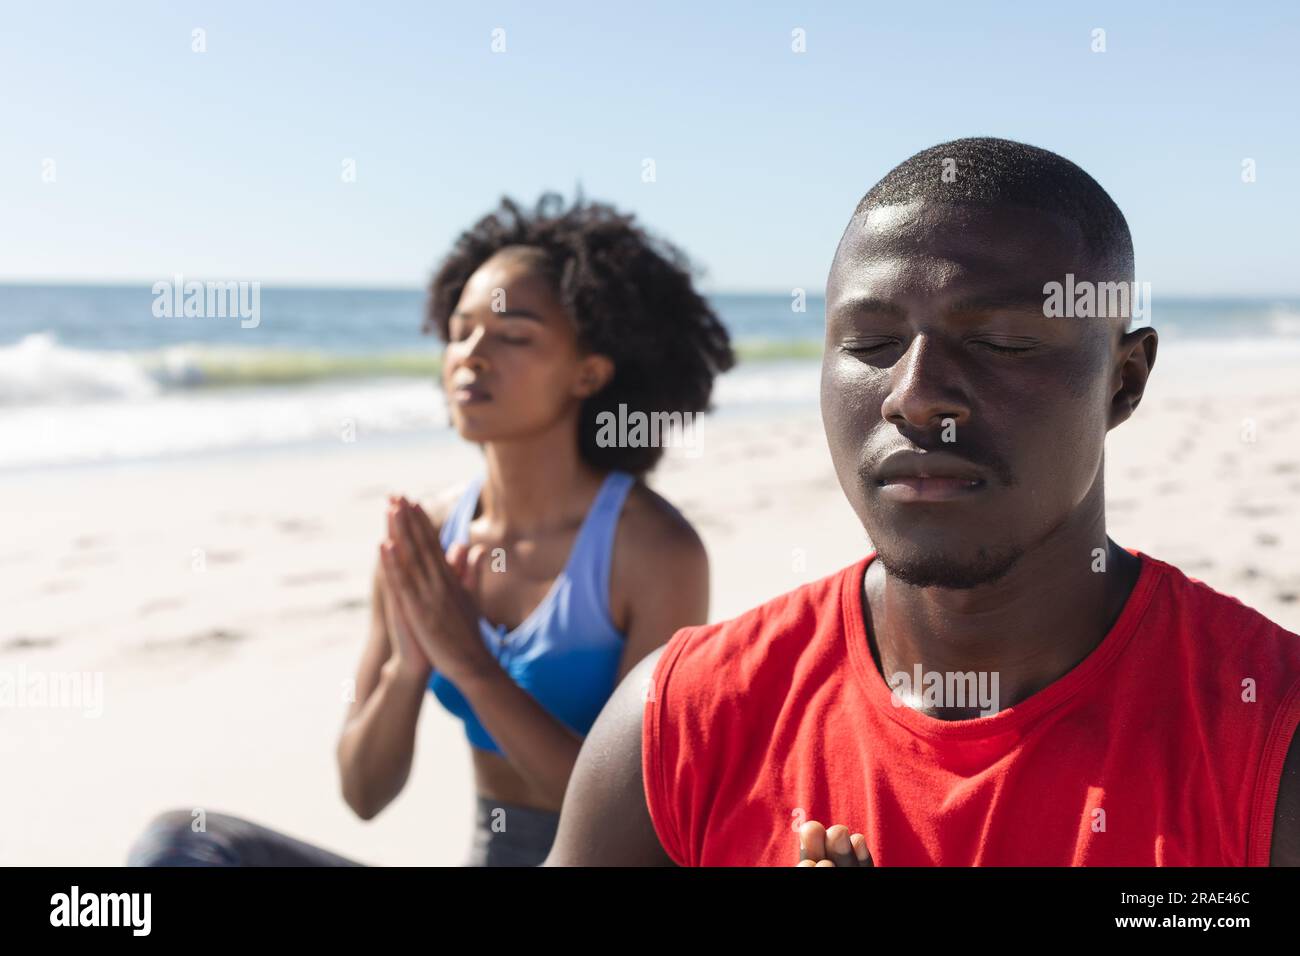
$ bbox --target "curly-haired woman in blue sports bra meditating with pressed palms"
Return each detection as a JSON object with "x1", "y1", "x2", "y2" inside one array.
[{"x1": 133, "y1": 194, "x2": 733, "y2": 866}]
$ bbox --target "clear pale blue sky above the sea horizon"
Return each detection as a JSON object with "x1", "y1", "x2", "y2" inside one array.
[{"x1": 0, "y1": 0, "x2": 1300, "y2": 295}]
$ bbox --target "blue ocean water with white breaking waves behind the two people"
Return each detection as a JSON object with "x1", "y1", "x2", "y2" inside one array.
[{"x1": 0, "y1": 284, "x2": 1300, "y2": 471}]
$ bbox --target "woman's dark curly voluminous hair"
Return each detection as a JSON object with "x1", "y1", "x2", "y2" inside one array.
[{"x1": 424, "y1": 193, "x2": 736, "y2": 475}]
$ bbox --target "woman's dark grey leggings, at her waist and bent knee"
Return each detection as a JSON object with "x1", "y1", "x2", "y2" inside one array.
[{"x1": 126, "y1": 797, "x2": 559, "y2": 866}]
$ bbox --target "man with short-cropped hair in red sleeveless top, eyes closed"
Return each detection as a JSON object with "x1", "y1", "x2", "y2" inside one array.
[{"x1": 547, "y1": 139, "x2": 1300, "y2": 866}]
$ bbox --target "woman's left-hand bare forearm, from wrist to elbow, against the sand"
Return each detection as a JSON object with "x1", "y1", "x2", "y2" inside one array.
[{"x1": 338, "y1": 658, "x2": 429, "y2": 819}]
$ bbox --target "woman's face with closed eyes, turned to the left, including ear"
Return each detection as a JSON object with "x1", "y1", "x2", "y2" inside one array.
[{"x1": 442, "y1": 248, "x2": 614, "y2": 442}]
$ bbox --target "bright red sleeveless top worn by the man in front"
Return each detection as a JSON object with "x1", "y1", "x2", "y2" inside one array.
[{"x1": 642, "y1": 549, "x2": 1300, "y2": 866}]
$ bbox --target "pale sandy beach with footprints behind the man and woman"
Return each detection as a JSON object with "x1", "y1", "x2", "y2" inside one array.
[{"x1": 0, "y1": 349, "x2": 1300, "y2": 865}]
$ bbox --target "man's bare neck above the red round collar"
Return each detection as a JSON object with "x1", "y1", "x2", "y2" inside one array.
[{"x1": 863, "y1": 516, "x2": 1140, "y2": 721}]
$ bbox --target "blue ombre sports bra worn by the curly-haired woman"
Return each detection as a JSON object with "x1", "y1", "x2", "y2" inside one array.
[{"x1": 429, "y1": 471, "x2": 636, "y2": 753}]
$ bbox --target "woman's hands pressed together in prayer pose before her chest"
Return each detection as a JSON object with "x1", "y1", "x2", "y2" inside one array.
[{"x1": 380, "y1": 497, "x2": 498, "y2": 683}]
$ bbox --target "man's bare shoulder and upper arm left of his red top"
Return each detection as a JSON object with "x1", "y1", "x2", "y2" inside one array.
[{"x1": 542, "y1": 648, "x2": 673, "y2": 866}]
